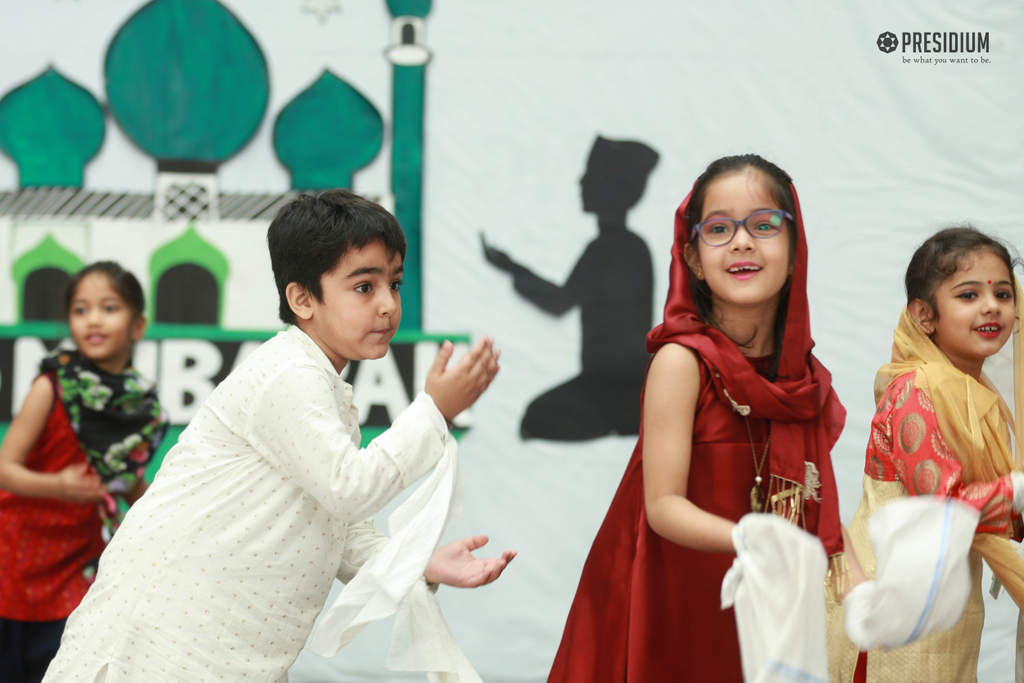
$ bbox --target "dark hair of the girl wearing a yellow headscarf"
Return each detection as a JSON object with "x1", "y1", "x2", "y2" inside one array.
[{"x1": 903, "y1": 225, "x2": 1021, "y2": 314}]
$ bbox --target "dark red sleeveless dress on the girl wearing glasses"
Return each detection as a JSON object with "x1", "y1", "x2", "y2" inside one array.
[{"x1": 548, "y1": 361, "x2": 769, "y2": 683}]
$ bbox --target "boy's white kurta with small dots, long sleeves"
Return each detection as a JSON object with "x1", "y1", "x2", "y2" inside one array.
[{"x1": 44, "y1": 327, "x2": 446, "y2": 683}]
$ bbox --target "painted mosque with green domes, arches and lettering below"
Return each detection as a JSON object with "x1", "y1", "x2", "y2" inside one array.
[{"x1": 0, "y1": 0, "x2": 469, "y2": 474}]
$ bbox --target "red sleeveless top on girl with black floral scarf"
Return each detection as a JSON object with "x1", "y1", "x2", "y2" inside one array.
[{"x1": 0, "y1": 378, "x2": 104, "y2": 622}]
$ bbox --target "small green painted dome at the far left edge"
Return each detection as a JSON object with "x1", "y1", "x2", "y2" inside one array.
[{"x1": 0, "y1": 69, "x2": 106, "y2": 187}]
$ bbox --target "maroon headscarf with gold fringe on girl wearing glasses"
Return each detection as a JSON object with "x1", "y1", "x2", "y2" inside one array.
[{"x1": 647, "y1": 183, "x2": 846, "y2": 556}]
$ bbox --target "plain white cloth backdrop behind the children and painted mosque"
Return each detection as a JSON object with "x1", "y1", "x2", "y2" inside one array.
[{"x1": 0, "y1": 0, "x2": 1024, "y2": 682}]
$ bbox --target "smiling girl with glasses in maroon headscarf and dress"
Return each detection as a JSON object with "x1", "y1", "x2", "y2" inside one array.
[{"x1": 548, "y1": 155, "x2": 846, "y2": 683}]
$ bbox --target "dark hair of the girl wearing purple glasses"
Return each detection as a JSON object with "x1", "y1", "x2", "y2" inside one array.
[{"x1": 683, "y1": 155, "x2": 797, "y2": 382}]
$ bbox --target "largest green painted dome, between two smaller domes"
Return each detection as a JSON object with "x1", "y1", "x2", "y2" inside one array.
[{"x1": 105, "y1": 0, "x2": 270, "y2": 163}]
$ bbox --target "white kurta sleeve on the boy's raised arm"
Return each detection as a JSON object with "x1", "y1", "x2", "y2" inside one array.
[{"x1": 245, "y1": 367, "x2": 444, "y2": 523}]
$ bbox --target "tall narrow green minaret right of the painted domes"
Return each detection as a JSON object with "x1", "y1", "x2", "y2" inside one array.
[{"x1": 387, "y1": 0, "x2": 431, "y2": 330}]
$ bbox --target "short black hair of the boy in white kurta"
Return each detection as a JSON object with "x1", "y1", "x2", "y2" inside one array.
[{"x1": 266, "y1": 189, "x2": 407, "y2": 325}]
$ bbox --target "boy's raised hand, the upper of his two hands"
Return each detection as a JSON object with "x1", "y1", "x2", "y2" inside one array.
[{"x1": 424, "y1": 337, "x2": 501, "y2": 422}]
